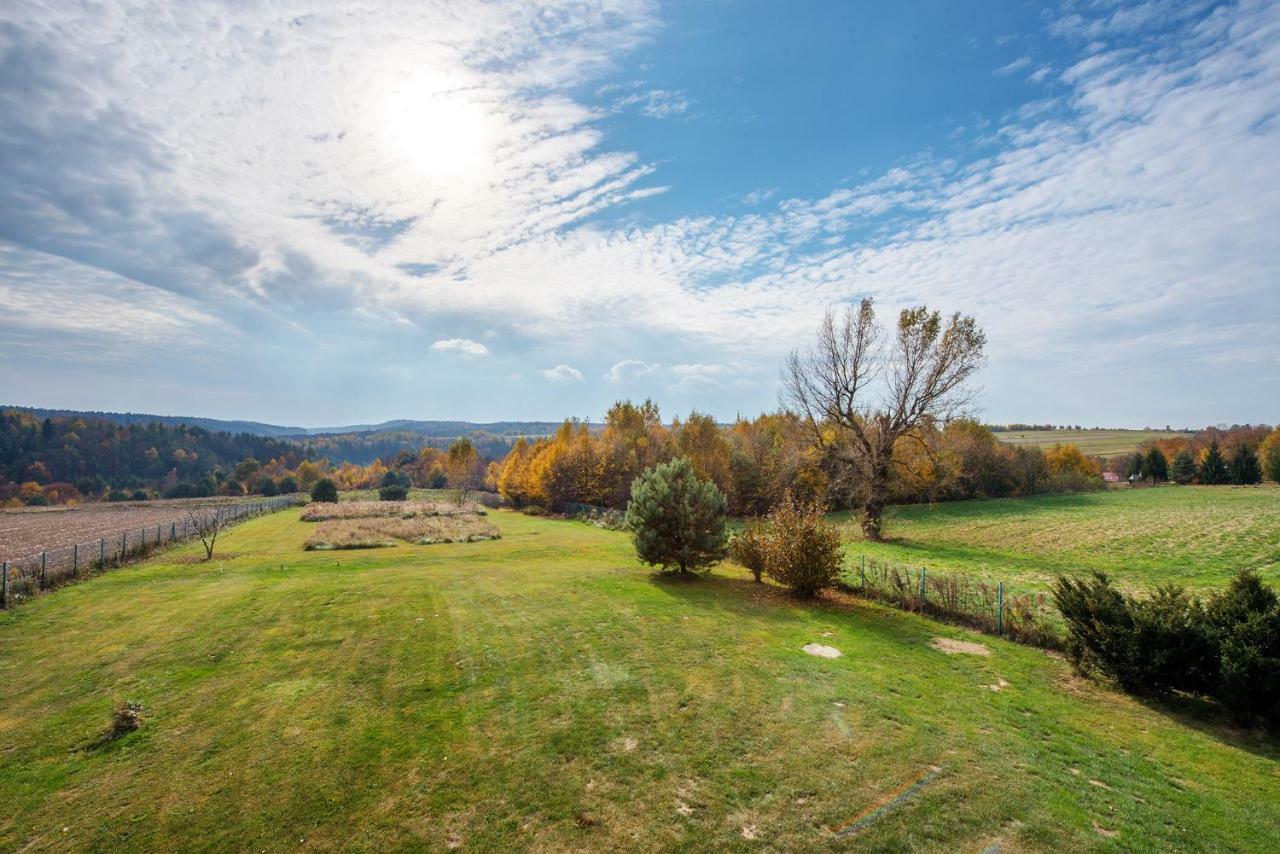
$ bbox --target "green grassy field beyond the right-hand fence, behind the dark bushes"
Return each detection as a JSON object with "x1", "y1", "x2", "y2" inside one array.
[{"x1": 846, "y1": 484, "x2": 1280, "y2": 599}]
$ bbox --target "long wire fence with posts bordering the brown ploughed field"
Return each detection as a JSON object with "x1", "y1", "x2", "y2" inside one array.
[{"x1": 0, "y1": 495, "x2": 296, "y2": 608}]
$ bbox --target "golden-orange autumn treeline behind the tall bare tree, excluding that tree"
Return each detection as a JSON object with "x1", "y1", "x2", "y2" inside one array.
[{"x1": 488, "y1": 401, "x2": 1102, "y2": 516}]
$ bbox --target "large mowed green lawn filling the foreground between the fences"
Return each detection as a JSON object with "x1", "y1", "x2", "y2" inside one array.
[{"x1": 0, "y1": 507, "x2": 1280, "y2": 851}]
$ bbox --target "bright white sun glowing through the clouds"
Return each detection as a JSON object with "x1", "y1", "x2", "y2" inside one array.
[{"x1": 383, "y1": 74, "x2": 495, "y2": 183}]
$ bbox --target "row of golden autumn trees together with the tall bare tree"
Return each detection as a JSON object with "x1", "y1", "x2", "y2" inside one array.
[{"x1": 488, "y1": 301, "x2": 1102, "y2": 536}]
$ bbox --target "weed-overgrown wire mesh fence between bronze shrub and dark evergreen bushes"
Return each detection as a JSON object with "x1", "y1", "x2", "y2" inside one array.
[{"x1": 841, "y1": 554, "x2": 1062, "y2": 649}]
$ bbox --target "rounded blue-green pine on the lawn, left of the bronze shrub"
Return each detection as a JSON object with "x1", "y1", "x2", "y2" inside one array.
[{"x1": 626, "y1": 457, "x2": 727, "y2": 572}]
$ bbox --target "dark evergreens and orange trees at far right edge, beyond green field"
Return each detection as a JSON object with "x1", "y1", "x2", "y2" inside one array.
[{"x1": 1108, "y1": 424, "x2": 1280, "y2": 485}]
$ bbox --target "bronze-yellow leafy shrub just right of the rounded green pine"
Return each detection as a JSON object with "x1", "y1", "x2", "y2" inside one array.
[{"x1": 764, "y1": 493, "x2": 844, "y2": 597}]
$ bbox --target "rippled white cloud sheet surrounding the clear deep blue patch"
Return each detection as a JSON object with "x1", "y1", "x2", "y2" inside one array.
[{"x1": 0, "y1": 0, "x2": 1280, "y2": 424}]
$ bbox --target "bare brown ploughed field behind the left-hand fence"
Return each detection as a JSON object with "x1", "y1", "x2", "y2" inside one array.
[{"x1": 0, "y1": 498, "x2": 244, "y2": 561}]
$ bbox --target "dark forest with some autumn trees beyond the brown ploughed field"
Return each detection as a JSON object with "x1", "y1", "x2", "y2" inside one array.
[{"x1": 0, "y1": 411, "x2": 303, "y2": 503}]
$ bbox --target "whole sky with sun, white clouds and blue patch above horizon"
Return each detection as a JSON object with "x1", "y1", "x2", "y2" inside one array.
[{"x1": 0, "y1": 0, "x2": 1280, "y2": 426}]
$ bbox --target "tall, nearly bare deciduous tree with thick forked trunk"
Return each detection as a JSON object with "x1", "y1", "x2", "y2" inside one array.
[{"x1": 782, "y1": 298, "x2": 987, "y2": 540}]
